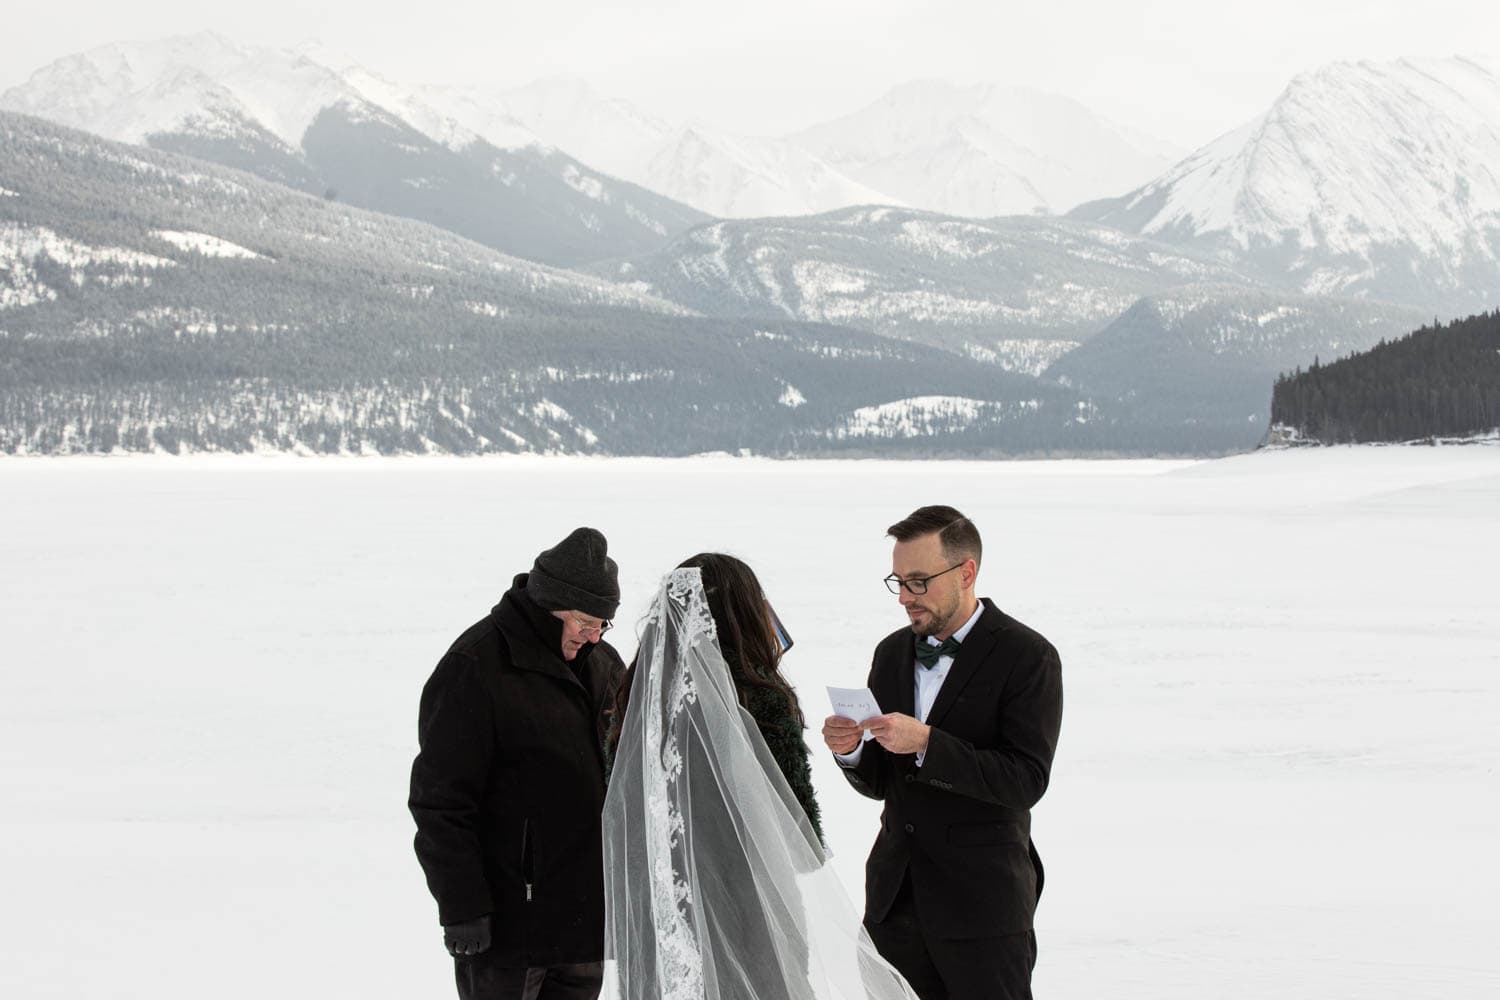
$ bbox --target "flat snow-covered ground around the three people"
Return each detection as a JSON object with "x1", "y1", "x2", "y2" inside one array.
[{"x1": 0, "y1": 447, "x2": 1500, "y2": 1000}]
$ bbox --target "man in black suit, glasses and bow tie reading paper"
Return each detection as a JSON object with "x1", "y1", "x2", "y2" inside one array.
[{"x1": 824, "y1": 507, "x2": 1062, "y2": 1000}]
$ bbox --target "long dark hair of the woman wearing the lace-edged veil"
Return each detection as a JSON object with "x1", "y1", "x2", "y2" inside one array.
[{"x1": 608, "y1": 552, "x2": 806, "y2": 757}]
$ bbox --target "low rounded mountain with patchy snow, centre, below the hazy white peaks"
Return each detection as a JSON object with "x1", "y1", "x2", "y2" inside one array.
[{"x1": 590, "y1": 208, "x2": 1245, "y2": 372}]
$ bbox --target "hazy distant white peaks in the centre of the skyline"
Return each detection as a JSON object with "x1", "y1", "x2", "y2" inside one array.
[{"x1": 426, "y1": 78, "x2": 1181, "y2": 219}]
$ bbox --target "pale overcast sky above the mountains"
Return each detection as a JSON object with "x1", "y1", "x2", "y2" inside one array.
[{"x1": 0, "y1": 0, "x2": 1500, "y2": 148}]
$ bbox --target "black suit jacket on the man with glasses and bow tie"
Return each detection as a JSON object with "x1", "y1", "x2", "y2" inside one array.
[{"x1": 845, "y1": 598, "x2": 1062, "y2": 939}]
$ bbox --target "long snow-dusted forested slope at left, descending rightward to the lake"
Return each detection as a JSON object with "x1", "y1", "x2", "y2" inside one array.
[{"x1": 0, "y1": 112, "x2": 1113, "y2": 454}]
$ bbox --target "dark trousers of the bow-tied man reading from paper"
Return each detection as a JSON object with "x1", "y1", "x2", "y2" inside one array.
[{"x1": 866, "y1": 876, "x2": 1037, "y2": 1000}]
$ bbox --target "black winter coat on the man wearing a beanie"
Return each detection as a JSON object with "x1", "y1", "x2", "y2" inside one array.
[{"x1": 410, "y1": 574, "x2": 623, "y2": 966}]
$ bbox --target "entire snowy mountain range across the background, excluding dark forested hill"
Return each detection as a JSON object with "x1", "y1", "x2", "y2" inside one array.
[{"x1": 0, "y1": 34, "x2": 1500, "y2": 454}]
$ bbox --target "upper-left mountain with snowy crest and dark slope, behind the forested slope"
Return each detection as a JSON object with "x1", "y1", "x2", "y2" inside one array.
[{"x1": 0, "y1": 33, "x2": 704, "y2": 264}]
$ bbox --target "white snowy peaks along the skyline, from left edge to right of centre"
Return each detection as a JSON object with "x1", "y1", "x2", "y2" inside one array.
[{"x1": 0, "y1": 33, "x2": 1179, "y2": 220}]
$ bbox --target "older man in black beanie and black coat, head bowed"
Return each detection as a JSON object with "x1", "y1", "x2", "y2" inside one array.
[{"x1": 408, "y1": 528, "x2": 624, "y2": 1000}]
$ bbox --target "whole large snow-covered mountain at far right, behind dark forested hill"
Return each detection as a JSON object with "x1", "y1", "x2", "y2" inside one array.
[{"x1": 1074, "y1": 58, "x2": 1500, "y2": 315}]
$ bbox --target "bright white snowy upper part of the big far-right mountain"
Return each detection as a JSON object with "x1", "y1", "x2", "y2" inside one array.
[{"x1": 1125, "y1": 58, "x2": 1500, "y2": 256}]
